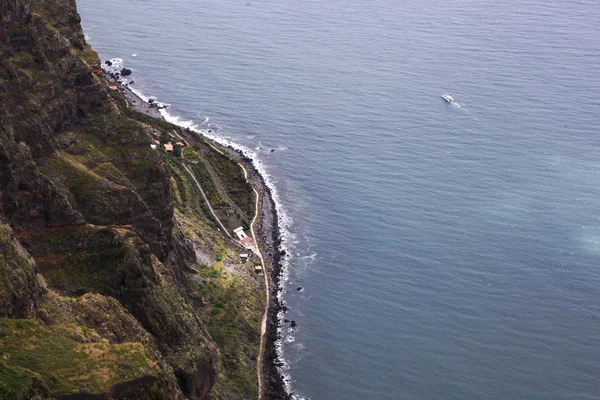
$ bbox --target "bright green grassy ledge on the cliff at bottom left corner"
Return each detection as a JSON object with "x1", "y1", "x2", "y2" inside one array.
[{"x1": 0, "y1": 319, "x2": 158, "y2": 398}]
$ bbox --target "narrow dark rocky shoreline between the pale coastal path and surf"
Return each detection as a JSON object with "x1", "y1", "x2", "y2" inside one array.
[{"x1": 116, "y1": 81, "x2": 292, "y2": 400}]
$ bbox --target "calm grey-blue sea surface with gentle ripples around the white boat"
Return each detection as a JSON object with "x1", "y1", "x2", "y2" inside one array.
[{"x1": 79, "y1": 0, "x2": 600, "y2": 400}]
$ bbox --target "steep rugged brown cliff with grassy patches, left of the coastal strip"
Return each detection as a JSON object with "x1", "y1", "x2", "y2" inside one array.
[{"x1": 0, "y1": 0, "x2": 230, "y2": 399}]
